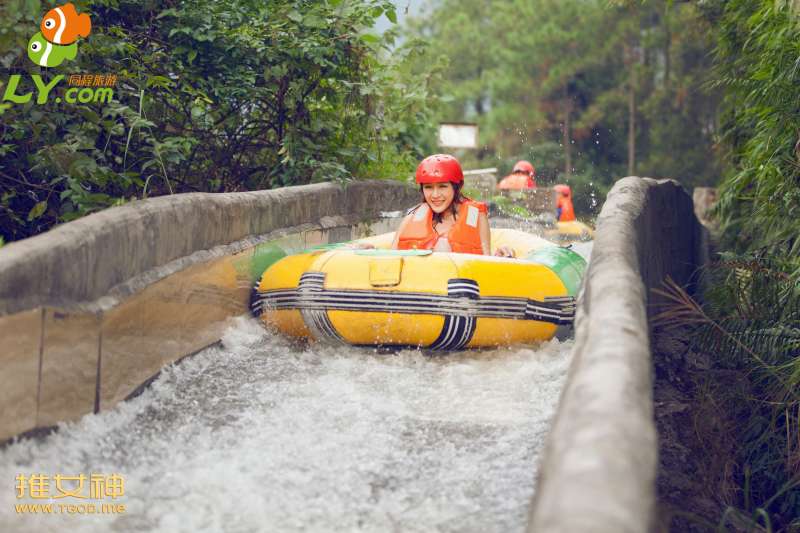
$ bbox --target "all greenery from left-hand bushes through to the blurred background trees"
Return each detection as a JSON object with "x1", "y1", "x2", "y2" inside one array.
[{"x1": 0, "y1": 0, "x2": 720, "y2": 241}]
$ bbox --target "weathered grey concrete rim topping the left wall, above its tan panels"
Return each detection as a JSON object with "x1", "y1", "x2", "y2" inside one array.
[{"x1": 0, "y1": 181, "x2": 418, "y2": 315}]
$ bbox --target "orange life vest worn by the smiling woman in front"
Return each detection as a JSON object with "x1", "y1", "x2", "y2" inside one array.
[{"x1": 397, "y1": 199, "x2": 486, "y2": 254}]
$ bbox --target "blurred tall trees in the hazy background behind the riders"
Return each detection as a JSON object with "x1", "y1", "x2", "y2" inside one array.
[{"x1": 410, "y1": 0, "x2": 722, "y2": 214}]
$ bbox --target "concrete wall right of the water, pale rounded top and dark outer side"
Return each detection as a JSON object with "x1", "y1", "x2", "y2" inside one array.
[{"x1": 528, "y1": 177, "x2": 704, "y2": 533}]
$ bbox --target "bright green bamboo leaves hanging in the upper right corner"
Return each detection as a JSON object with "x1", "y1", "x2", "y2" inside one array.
[{"x1": 706, "y1": 0, "x2": 800, "y2": 264}]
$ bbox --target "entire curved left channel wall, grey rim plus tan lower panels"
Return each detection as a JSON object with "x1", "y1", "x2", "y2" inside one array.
[{"x1": 0, "y1": 181, "x2": 412, "y2": 442}]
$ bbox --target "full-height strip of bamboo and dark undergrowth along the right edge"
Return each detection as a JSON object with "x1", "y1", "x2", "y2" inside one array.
[{"x1": 698, "y1": 0, "x2": 800, "y2": 531}]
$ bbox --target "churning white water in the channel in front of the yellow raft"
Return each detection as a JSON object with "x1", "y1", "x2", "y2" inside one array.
[{"x1": 0, "y1": 319, "x2": 572, "y2": 533}]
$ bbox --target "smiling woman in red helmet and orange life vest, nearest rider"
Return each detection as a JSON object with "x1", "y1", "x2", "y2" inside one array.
[{"x1": 392, "y1": 154, "x2": 513, "y2": 257}]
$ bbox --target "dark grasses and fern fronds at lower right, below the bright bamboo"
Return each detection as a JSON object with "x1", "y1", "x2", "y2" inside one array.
[{"x1": 656, "y1": 254, "x2": 800, "y2": 531}]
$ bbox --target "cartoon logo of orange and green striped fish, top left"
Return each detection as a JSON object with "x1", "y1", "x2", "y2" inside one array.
[{"x1": 28, "y1": 3, "x2": 92, "y2": 67}]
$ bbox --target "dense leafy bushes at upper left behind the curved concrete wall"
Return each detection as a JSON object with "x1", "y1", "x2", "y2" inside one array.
[{"x1": 0, "y1": 0, "x2": 432, "y2": 240}]
